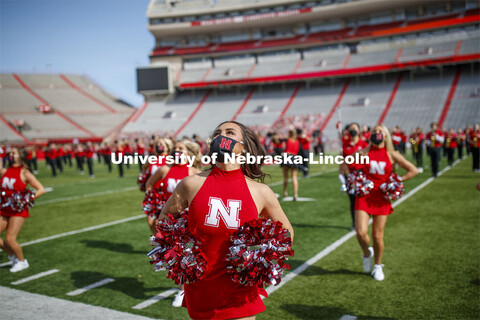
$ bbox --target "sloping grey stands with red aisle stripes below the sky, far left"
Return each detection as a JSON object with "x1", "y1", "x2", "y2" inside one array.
[{"x1": 0, "y1": 74, "x2": 134, "y2": 141}]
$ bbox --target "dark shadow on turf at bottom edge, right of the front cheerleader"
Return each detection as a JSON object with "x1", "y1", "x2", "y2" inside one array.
[{"x1": 280, "y1": 304, "x2": 393, "y2": 320}]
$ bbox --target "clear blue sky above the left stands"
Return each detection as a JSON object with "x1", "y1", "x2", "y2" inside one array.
[{"x1": 0, "y1": 0, "x2": 154, "y2": 107}]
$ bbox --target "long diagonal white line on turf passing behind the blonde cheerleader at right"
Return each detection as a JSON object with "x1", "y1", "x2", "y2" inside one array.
[{"x1": 267, "y1": 160, "x2": 460, "y2": 295}]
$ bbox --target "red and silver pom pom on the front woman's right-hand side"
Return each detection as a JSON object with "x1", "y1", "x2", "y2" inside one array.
[{"x1": 227, "y1": 218, "x2": 294, "y2": 287}]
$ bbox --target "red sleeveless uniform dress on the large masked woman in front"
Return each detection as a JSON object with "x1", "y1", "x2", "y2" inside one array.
[{"x1": 183, "y1": 166, "x2": 267, "y2": 319}]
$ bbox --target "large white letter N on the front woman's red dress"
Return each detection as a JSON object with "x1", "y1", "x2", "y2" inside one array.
[{"x1": 205, "y1": 197, "x2": 242, "y2": 229}]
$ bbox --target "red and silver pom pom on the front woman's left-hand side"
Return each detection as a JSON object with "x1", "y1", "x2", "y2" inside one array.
[{"x1": 148, "y1": 212, "x2": 207, "y2": 285}]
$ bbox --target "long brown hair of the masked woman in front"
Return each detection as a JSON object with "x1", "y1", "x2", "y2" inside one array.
[{"x1": 210, "y1": 121, "x2": 267, "y2": 183}]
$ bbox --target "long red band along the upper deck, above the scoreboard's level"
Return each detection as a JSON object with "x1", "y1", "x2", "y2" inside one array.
[{"x1": 151, "y1": 9, "x2": 480, "y2": 57}]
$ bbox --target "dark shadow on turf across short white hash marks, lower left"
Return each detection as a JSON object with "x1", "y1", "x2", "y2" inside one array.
[{"x1": 70, "y1": 271, "x2": 171, "y2": 300}]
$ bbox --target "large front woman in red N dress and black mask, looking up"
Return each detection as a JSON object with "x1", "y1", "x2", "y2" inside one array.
[{"x1": 160, "y1": 121, "x2": 293, "y2": 319}]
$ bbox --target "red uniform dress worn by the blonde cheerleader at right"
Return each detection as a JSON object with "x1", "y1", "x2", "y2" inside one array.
[{"x1": 355, "y1": 145, "x2": 393, "y2": 216}]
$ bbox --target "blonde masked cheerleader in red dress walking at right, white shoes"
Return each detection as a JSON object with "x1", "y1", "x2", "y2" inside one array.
[{"x1": 348, "y1": 125, "x2": 418, "y2": 281}]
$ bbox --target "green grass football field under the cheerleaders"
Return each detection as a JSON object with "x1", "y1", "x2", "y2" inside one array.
[{"x1": 0, "y1": 154, "x2": 480, "y2": 319}]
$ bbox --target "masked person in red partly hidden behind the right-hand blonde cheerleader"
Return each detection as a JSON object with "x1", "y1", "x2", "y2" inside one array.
[{"x1": 338, "y1": 122, "x2": 368, "y2": 230}]
